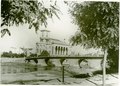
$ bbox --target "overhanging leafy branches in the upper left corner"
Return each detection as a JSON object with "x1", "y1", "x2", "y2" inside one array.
[{"x1": 1, "y1": 0, "x2": 60, "y2": 37}]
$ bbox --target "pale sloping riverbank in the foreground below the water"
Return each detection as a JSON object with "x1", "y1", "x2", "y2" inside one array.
[{"x1": 2, "y1": 72, "x2": 119, "y2": 86}]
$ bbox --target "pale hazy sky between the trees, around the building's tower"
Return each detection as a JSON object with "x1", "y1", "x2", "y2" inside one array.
[{"x1": 0, "y1": 1, "x2": 78, "y2": 52}]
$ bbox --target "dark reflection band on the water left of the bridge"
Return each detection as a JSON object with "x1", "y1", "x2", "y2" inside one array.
[{"x1": 1, "y1": 63, "x2": 41, "y2": 74}]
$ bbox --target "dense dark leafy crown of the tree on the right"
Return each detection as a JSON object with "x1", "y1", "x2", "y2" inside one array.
[{"x1": 70, "y1": 2, "x2": 119, "y2": 70}]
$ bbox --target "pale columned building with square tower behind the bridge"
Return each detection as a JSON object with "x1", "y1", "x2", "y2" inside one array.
[{"x1": 36, "y1": 30, "x2": 70, "y2": 56}]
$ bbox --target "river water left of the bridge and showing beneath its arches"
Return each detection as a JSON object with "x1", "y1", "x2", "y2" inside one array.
[{"x1": 1, "y1": 58, "x2": 100, "y2": 74}]
